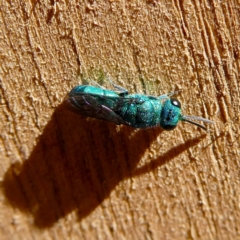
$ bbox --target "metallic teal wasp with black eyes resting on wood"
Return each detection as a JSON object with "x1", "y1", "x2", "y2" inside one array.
[{"x1": 66, "y1": 82, "x2": 213, "y2": 131}]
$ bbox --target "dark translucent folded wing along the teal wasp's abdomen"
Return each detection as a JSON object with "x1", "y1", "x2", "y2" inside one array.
[{"x1": 66, "y1": 93, "x2": 129, "y2": 125}]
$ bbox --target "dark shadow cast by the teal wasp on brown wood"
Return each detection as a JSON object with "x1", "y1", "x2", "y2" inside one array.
[{"x1": 3, "y1": 102, "x2": 203, "y2": 228}]
